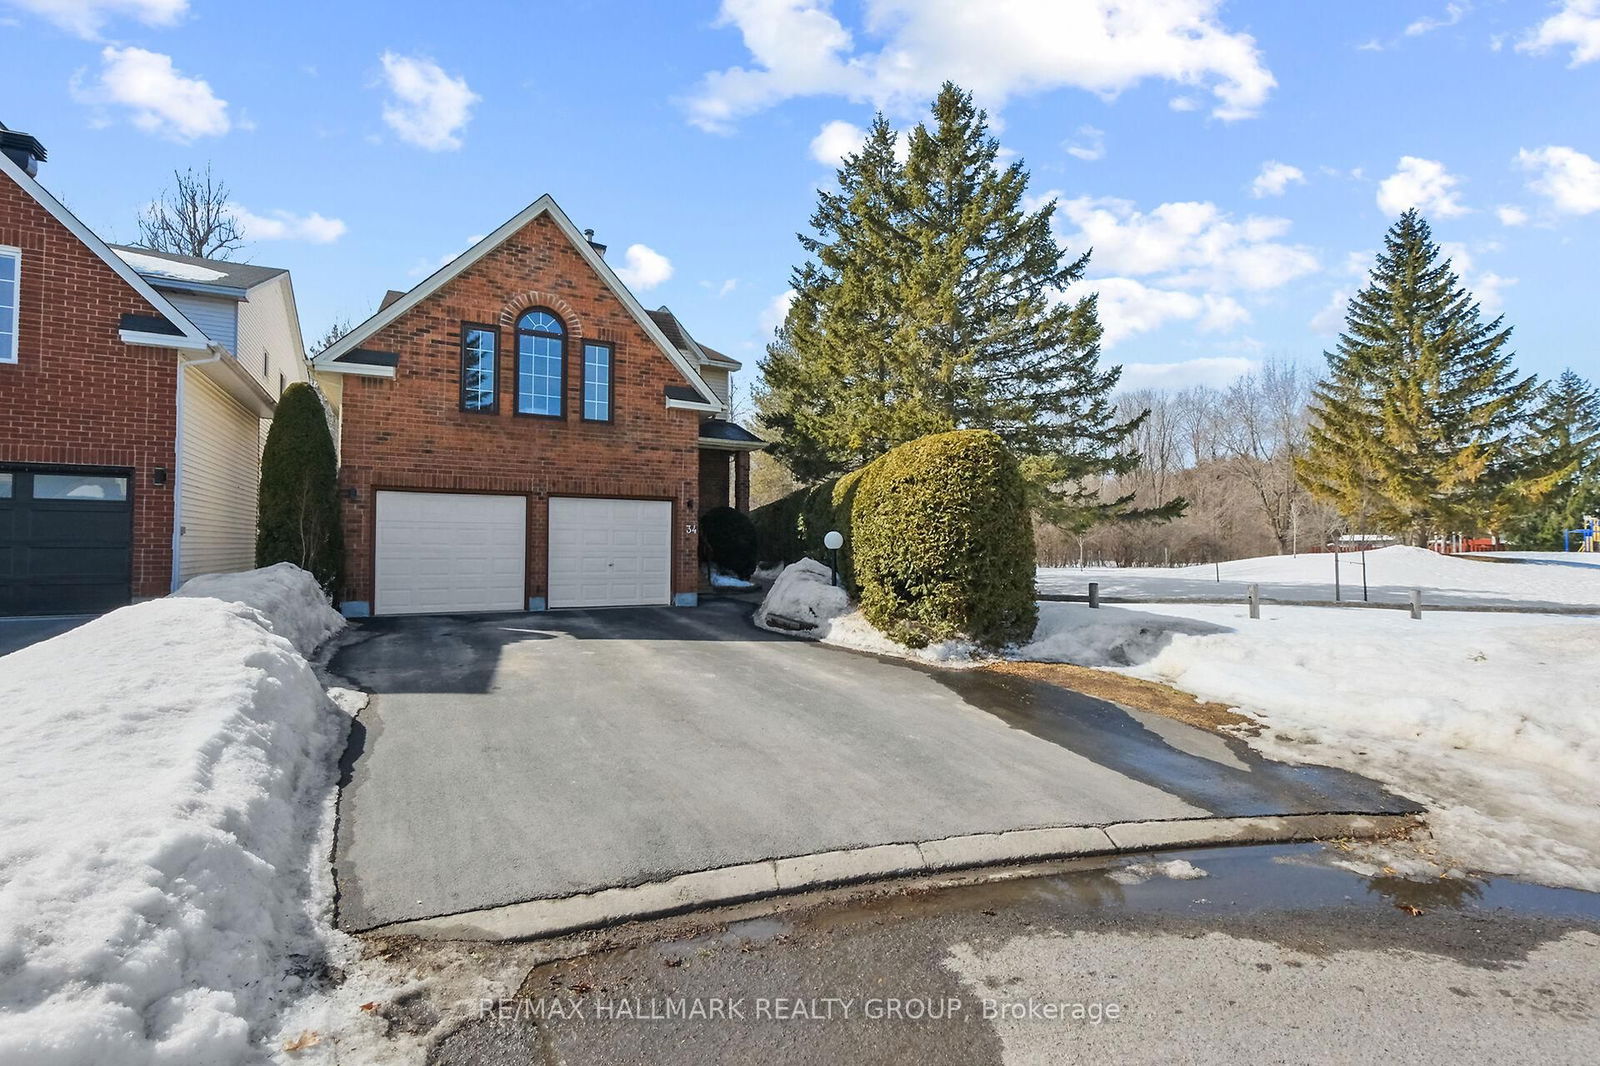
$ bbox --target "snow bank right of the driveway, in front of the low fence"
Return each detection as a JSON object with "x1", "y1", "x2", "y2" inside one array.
[{"x1": 1019, "y1": 598, "x2": 1600, "y2": 892}]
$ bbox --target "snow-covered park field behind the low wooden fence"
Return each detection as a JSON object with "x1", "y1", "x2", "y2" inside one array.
[{"x1": 1038, "y1": 546, "x2": 1600, "y2": 607}]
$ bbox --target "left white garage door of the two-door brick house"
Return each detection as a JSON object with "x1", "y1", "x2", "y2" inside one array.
[{"x1": 373, "y1": 491, "x2": 528, "y2": 615}]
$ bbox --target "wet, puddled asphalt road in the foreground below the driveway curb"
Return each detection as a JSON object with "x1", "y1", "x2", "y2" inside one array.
[{"x1": 429, "y1": 845, "x2": 1600, "y2": 1066}]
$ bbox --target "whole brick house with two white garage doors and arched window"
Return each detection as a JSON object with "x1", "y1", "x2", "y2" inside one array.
[{"x1": 312, "y1": 197, "x2": 763, "y2": 616}]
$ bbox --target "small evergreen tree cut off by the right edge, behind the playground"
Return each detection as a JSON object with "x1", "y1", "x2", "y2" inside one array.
[{"x1": 1507, "y1": 370, "x2": 1600, "y2": 549}]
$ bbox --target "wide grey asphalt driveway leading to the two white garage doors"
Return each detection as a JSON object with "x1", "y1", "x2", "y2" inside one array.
[{"x1": 333, "y1": 600, "x2": 1414, "y2": 930}]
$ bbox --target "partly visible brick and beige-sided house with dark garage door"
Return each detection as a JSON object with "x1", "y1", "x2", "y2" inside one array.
[{"x1": 0, "y1": 126, "x2": 309, "y2": 615}]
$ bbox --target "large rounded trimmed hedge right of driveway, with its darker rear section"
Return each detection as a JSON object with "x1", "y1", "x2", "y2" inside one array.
[{"x1": 750, "y1": 429, "x2": 1038, "y2": 647}]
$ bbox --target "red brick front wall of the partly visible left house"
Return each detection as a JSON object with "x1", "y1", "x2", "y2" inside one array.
[{"x1": 0, "y1": 174, "x2": 178, "y2": 595}]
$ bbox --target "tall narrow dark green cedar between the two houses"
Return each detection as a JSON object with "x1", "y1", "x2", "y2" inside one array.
[{"x1": 256, "y1": 381, "x2": 344, "y2": 592}]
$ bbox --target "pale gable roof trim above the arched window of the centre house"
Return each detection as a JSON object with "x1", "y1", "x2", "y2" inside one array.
[{"x1": 310, "y1": 194, "x2": 717, "y2": 410}]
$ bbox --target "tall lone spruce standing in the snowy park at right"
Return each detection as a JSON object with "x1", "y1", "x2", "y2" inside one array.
[{"x1": 1298, "y1": 210, "x2": 1557, "y2": 543}]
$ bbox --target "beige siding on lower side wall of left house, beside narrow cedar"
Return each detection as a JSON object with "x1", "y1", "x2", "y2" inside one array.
[{"x1": 179, "y1": 368, "x2": 261, "y2": 581}]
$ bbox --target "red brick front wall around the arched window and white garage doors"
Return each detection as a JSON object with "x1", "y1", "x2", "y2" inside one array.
[{"x1": 339, "y1": 209, "x2": 699, "y2": 603}]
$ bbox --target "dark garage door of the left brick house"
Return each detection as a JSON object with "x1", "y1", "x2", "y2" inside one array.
[{"x1": 0, "y1": 467, "x2": 133, "y2": 615}]
